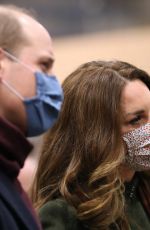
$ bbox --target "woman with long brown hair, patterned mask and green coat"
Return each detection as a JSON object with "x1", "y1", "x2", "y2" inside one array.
[{"x1": 32, "y1": 61, "x2": 150, "y2": 230}]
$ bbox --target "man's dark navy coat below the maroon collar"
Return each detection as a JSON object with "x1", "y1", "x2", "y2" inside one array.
[{"x1": 0, "y1": 172, "x2": 40, "y2": 230}]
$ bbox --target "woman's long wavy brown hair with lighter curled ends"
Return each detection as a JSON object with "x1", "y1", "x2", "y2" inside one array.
[{"x1": 32, "y1": 61, "x2": 150, "y2": 230}]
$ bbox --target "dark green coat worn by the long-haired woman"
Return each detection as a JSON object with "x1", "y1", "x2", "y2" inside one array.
[{"x1": 39, "y1": 194, "x2": 150, "y2": 230}]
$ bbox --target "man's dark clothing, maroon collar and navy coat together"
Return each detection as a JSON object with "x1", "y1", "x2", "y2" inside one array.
[{"x1": 0, "y1": 117, "x2": 41, "y2": 230}]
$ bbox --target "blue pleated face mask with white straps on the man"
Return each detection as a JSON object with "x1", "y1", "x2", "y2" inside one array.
[{"x1": 2, "y1": 51, "x2": 63, "y2": 137}]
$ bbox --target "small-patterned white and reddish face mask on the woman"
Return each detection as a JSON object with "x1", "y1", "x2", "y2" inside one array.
[{"x1": 123, "y1": 123, "x2": 150, "y2": 171}]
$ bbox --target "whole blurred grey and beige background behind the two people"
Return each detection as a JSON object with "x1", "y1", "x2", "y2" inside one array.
[{"x1": 3, "y1": 0, "x2": 150, "y2": 190}]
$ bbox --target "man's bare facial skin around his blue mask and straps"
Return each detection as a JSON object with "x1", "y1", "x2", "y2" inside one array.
[{"x1": 0, "y1": 16, "x2": 54, "y2": 131}]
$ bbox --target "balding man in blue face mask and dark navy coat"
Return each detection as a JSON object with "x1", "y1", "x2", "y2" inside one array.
[{"x1": 0, "y1": 6, "x2": 62, "y2": 230}]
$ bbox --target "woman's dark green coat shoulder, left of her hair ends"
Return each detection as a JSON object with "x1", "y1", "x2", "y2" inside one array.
[{"x1": 39, "y1": 199, "x2": 83, "y2": 230}]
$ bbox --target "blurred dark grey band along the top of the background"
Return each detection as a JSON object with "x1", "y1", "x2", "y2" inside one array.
[{"x1": 0, "y1": 0, "x2": 150, "y2": 36}]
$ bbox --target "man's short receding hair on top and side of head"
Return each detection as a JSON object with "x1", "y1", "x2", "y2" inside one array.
[{"x1": 0, "y1": 5, "x2": 34, "y2": 54}]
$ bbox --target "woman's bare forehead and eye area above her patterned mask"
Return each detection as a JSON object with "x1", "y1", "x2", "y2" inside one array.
[{"x1": 121, "y1": 80, "x2": 150, "y2": 134}]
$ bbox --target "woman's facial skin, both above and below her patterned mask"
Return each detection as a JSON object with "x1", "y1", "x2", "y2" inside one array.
[{"x1": 120, "y1": 80, "x2": 150, "y2": 178}]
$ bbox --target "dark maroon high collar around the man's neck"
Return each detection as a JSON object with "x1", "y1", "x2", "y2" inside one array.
[{"x1": 0, "y1": 117, "x2": 33, "y2": 177}]
